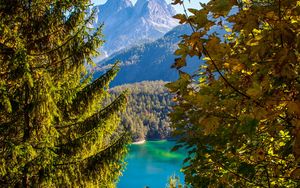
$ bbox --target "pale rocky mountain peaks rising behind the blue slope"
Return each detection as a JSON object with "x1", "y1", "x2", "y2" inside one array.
[{"x1": 94, "y1": 0, "x2": 178, "y2": 55}]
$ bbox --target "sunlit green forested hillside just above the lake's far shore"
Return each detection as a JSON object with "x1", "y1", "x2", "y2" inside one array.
[{"x1": 111, "y1": 81, "x2": 172, "y2": 141}]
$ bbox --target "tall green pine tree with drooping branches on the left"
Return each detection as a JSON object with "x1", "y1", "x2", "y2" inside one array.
[{"x1": 0, "y1": 0, "x2": 128, "y2": 187}]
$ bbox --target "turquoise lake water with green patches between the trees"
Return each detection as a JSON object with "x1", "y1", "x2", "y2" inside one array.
[{"x1": 117, "y1": 140, "x2": 186, "y2": 188}]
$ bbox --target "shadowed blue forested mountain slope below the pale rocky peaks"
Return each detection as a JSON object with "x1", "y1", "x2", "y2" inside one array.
[{"x1": 94, "y1": 25, "x2": 199, "y2": 86}]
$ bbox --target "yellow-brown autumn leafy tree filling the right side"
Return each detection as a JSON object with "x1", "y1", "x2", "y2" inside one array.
[{"x1": 167, "y1": 0, "x2": 300, "y2": 187}]
